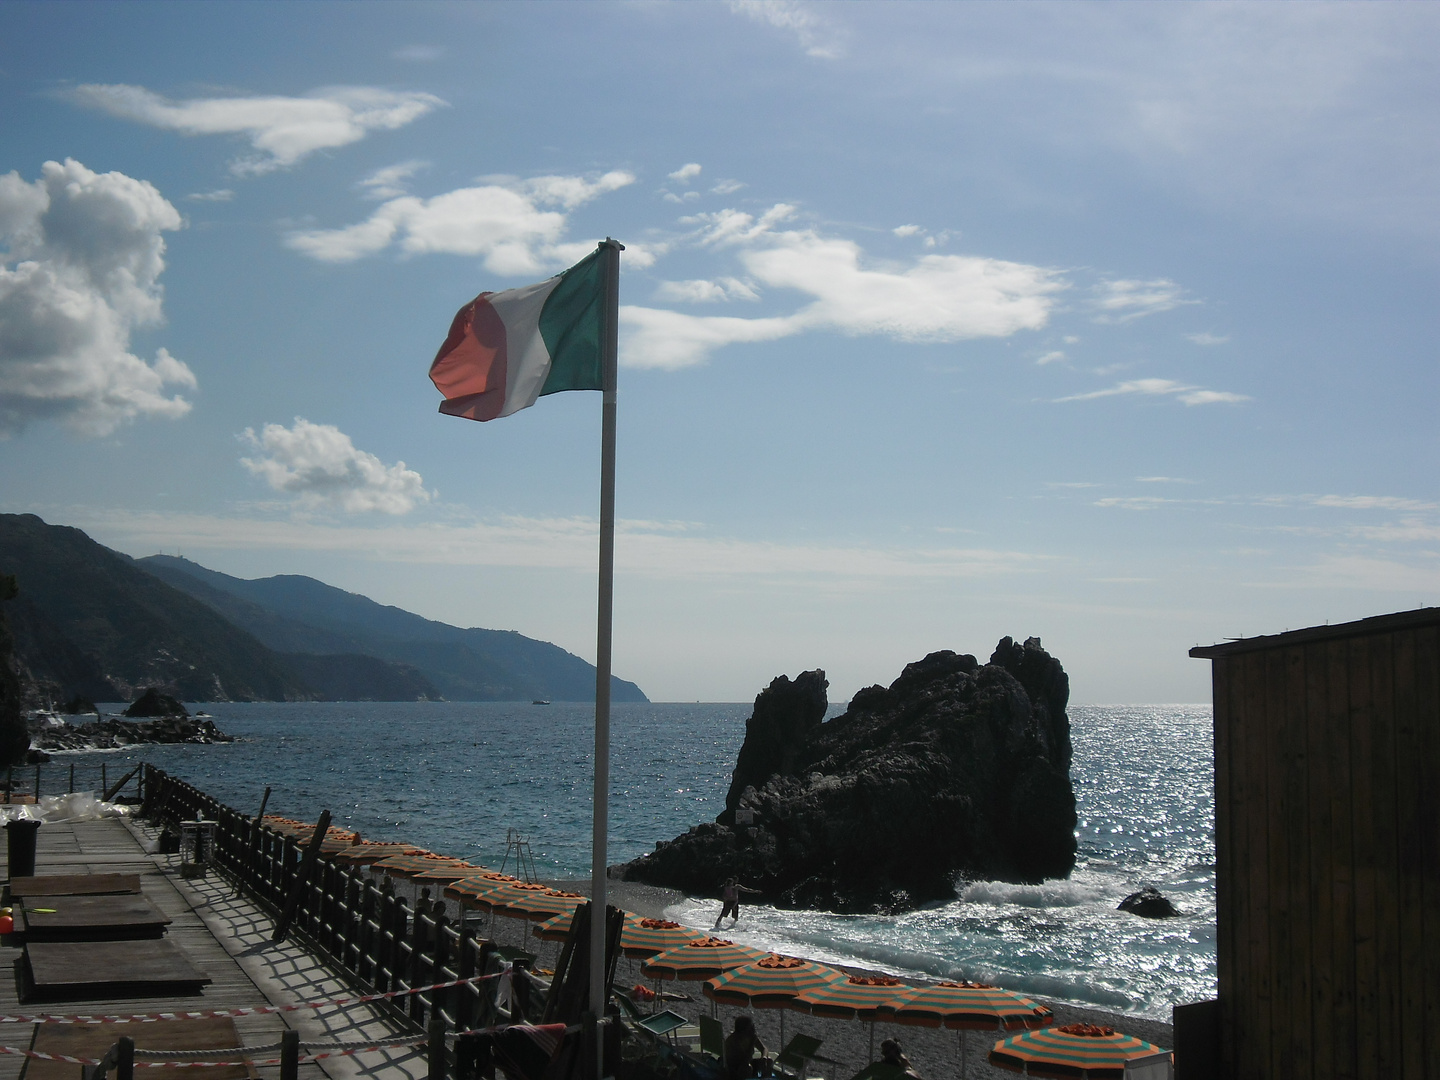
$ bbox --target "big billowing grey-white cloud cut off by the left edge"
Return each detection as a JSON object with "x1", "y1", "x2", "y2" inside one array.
[{"x1": 0, "y1": 160, "x2": 196, "y2": 435}]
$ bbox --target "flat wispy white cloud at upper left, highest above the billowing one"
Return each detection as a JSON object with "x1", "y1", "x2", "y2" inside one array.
[{"x1": 72, "y1": 84, "x2": 445, "y2": 176}]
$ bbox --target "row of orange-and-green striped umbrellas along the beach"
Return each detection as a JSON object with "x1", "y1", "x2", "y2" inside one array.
[{"x1": 266, "y1": 818, "x2": 1162, "y2": 1079}]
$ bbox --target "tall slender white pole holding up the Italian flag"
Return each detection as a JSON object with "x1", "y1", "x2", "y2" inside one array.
[{"x1": 590, "y1": 236, "x2": 625, "y2": 1080}]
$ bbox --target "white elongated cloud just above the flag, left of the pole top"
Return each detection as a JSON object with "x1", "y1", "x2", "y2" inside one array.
[{"x1": 285, "y1": 171, "x2": 644, "y2": 275}]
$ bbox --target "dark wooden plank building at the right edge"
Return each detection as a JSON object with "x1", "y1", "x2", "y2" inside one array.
[{"x1": 1176, "y1": 608, "x2": 1440, "y2": 1080}]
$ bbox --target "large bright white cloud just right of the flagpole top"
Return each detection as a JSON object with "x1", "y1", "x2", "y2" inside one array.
[{"x1": 621, "y1": 203, "x2": 1066, "y2": 369}]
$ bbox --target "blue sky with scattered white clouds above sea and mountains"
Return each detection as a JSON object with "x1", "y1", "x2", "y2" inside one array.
[{"x1": 0, "y1": 3, "x2": 1440, "y2": 701}]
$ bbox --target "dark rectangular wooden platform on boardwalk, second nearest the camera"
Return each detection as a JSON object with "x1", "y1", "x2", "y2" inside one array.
[{"x1": 20, "y1": 937, "x2": 212, "y2": 1001}]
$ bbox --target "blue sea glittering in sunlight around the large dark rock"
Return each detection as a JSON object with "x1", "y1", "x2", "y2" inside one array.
[{"x1": 70, "y1": 701, "x2": 1215, "y2": 1021}]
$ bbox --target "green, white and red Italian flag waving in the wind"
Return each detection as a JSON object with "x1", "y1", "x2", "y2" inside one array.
[{"x1": 431, "y1": 249, "x2": 605, "y2": 420}]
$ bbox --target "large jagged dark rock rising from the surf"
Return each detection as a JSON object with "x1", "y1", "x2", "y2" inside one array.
[{"x1": 619, "y1": 638, "x2": 1076, "y2": 912}]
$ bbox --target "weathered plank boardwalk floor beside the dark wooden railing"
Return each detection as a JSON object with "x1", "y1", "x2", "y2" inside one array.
[{"x1": 0, "y1": 819, "x2": 426, "y2": 1080}]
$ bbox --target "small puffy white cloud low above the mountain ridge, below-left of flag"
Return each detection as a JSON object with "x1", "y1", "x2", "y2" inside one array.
[{"x1": 240, "y1": 416, "x2": 431, "y2": 514}]
